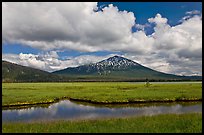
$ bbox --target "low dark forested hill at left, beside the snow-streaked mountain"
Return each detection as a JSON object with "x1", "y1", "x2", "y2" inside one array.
[{"x1": 2, "y1": 61, "x2": 67, "y2": 82}]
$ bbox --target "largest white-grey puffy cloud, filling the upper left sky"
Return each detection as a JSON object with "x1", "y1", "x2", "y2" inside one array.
[{"x1": 2, "y1": 2, "x2": 145, "y2": 52}]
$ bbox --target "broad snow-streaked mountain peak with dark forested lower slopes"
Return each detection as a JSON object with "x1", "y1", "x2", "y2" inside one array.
[{"x1": 53, "y1": 56, "x2": 202, "y2": 81}]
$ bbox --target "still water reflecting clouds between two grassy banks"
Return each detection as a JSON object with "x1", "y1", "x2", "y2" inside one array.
[{"x1": 2, "y1": 100, "x2": 202, "y2": 122}]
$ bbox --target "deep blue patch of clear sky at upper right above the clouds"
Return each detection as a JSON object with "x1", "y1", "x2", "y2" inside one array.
[{"x1": 98, "y1": 2, "x2": 202, "y2": 25}]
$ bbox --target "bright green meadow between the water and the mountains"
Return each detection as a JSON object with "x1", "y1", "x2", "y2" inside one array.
[{"x1": 2, "y1": 82, "x2": 202, "y2": 106}]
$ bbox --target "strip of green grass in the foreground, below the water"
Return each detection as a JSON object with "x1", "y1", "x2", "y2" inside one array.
[{"x1": 2, "y1": 113, "x2": 202, "y2": 133}]
